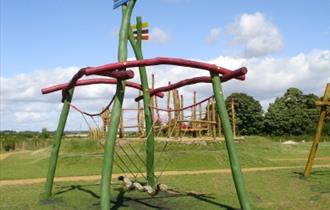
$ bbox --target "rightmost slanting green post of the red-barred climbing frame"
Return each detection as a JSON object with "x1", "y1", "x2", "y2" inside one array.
[{"x1": 211, "y1": 72, "x2": 251, "y2": 210}]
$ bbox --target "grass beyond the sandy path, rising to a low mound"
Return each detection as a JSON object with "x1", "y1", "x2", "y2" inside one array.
[{"x1": 0, "y1": 137, "x2": 330, "y2": 179}]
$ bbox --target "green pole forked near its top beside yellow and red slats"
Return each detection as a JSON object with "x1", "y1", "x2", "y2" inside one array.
[{"x1": 129, "y1": 17, "x2": 155, "y2": 187}]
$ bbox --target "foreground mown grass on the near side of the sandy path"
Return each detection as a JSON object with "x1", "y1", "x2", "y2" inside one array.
[{"x1": 0, "y1": 169, "x2": 330, "y2": 210}]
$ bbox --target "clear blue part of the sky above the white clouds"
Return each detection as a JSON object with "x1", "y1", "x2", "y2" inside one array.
[{"x1": 1, "y1": 0, "x2": 330, "y2": 76}]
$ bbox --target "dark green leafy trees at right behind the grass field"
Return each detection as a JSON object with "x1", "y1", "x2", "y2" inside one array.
[{"x1": 226, "y1": 88, "x2": 330, "y2": 136}]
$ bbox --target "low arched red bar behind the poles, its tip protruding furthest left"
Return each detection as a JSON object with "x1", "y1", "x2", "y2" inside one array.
[{"x1": 41, "y1": 78, "x2": 164, "y2": 98}]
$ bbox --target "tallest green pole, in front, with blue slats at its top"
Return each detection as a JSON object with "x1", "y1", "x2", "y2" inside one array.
[{"x1": 101, "y1": 0, "x2": 136, "y2": 210}]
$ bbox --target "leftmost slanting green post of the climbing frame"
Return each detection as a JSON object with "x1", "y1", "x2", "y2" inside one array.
[{"x1": 43, "y1": 88, "x2": 74, "y2": 199}]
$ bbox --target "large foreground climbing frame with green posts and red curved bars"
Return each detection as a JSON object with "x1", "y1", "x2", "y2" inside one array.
[{"x1": 42, "y1": 0, "x2": 251, "y2": 210}]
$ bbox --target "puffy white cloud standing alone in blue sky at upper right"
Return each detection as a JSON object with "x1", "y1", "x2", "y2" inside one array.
[{"x1": 230, "y1": 12, "x2": 284, "y2": 57}]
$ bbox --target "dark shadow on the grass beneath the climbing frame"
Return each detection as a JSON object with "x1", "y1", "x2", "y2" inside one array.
[{"x1": 54, "y1": 184, "x2": 238, "y2": 210}]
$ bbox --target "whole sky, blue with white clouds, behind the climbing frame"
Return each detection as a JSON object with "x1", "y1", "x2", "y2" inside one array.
[{"x1": 0, "y1": 0, "x2": 330, "y2": 131}]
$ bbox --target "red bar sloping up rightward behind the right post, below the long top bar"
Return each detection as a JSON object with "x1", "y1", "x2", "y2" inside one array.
[{"x1": 135, "y1": 67, "x2": 247, "y2": 101}]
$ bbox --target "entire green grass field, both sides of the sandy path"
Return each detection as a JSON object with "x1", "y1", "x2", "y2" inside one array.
[{"x1": 0, "y1": 137, "x2": 330, "y2": 210}]
